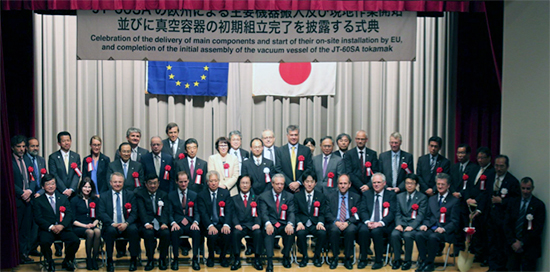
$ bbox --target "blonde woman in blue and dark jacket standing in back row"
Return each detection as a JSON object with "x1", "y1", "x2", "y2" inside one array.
[{"x1": 82, "y1": 135, "x2": 111, "y2": 195}]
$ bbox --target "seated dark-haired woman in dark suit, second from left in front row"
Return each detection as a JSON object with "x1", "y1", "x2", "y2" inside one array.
[{"x1": 71, "y1": 177, "x2": 101, "y2": 270}]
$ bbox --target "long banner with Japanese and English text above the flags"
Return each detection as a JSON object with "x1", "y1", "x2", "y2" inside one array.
[{"x1": 77, "y1": 10, "x2": 416, "y2": 62}]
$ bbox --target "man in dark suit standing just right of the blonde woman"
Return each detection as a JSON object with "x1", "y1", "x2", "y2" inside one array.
[{"x1": 107, "y1": 142, "x2": 144, "y2": 191}]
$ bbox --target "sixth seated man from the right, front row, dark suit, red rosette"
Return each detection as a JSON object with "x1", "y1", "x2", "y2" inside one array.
[{"x1": 258, "y1": 174, "x2": 298, "y2": 272}]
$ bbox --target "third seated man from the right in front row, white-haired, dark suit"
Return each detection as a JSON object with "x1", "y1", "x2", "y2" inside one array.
[{"x1": 357, "y1": 173, "x2": 397, "y2": 270}]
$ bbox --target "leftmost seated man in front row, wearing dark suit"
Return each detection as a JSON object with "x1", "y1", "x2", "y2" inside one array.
[{"x1": 33, "y1": 174, "x2": 80, "y2": 271}]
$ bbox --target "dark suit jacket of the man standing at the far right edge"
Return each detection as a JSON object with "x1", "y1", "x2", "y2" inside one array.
[{"x1": 504, "y1": 196, "x2": 546, "y2": 258}]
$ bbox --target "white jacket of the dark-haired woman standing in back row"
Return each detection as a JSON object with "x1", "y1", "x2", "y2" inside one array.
[{"x1": 205, "y1": 153, "x2": 239, "y2": 196}]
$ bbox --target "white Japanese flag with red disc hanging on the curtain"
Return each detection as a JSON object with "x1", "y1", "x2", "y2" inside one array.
[{"x1": 252, "y1": 62, "x2": 336, "y2": 97}]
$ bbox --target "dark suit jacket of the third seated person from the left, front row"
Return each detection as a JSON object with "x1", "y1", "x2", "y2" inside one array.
[{"x1": 99, "y1": 189, "x2": 138, "y2": 225}]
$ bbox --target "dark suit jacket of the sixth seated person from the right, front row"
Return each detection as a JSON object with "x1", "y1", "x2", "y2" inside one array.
[{"x1": 258, "y1": 188, "x2": 296, "y2": 226}]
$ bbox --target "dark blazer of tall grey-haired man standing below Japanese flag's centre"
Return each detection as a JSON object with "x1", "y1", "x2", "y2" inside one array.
[{"x1": 275, "y1": 144, "x2": 313, "y2": 188}]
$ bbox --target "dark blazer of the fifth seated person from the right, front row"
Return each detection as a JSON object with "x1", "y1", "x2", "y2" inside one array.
[{"x1": 294, "y1": 189, "x2": 328, "y2": 226}]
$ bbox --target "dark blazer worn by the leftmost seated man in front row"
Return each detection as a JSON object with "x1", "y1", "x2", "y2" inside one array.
[{"x1": 33, "y1": 192, "x2": 74, "y2": 231}]
